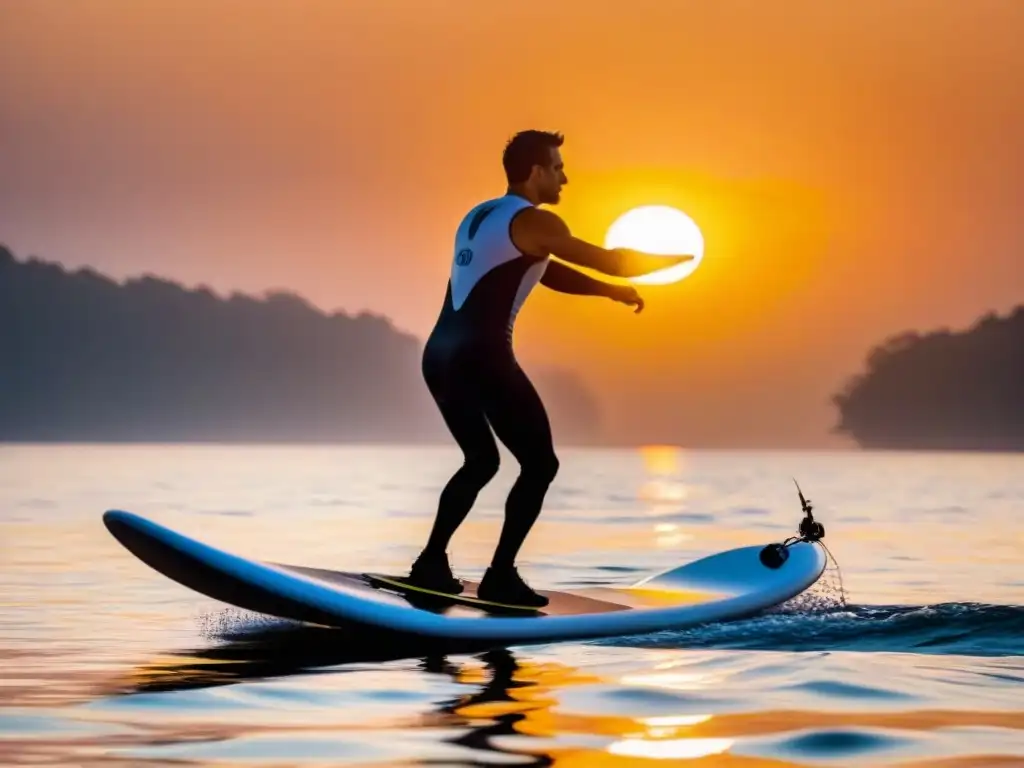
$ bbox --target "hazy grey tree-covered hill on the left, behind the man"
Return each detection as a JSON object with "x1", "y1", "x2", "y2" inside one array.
[{"x1": 0, "y1": 247, "x2": 597, "y2": 442}]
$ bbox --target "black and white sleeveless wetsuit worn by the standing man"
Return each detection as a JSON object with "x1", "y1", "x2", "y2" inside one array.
[{"x1": 423, "y1": 195, "x2": 558, "y2": 568}]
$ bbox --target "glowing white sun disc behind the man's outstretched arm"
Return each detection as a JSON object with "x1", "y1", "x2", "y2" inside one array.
[{"x1": 604, "y1": 206, "x2": 703, "y2": 285}]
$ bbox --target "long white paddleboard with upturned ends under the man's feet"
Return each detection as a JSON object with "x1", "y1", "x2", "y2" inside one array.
[{"x1": 103, "y1": 510, "x2": 826, "y2": 643}]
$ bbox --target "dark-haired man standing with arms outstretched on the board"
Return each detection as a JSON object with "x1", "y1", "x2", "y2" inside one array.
[{"x1": 409, "y1": 130, "x2": 693, "y2": 607}]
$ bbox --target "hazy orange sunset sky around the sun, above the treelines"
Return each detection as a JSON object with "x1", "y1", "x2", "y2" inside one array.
[{"x1": 0, "y1": 0, "x2": 1024, "y2": 445}]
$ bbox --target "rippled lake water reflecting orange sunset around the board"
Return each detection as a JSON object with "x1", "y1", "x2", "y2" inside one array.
[{"x1": 0, "y1": 445, "x2": 1024, "y2": 768}]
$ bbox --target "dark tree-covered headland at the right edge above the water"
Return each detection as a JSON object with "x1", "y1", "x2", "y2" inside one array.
[{"x1": 833, "y1": 305, "x2": 1024, "y2": 451}]
